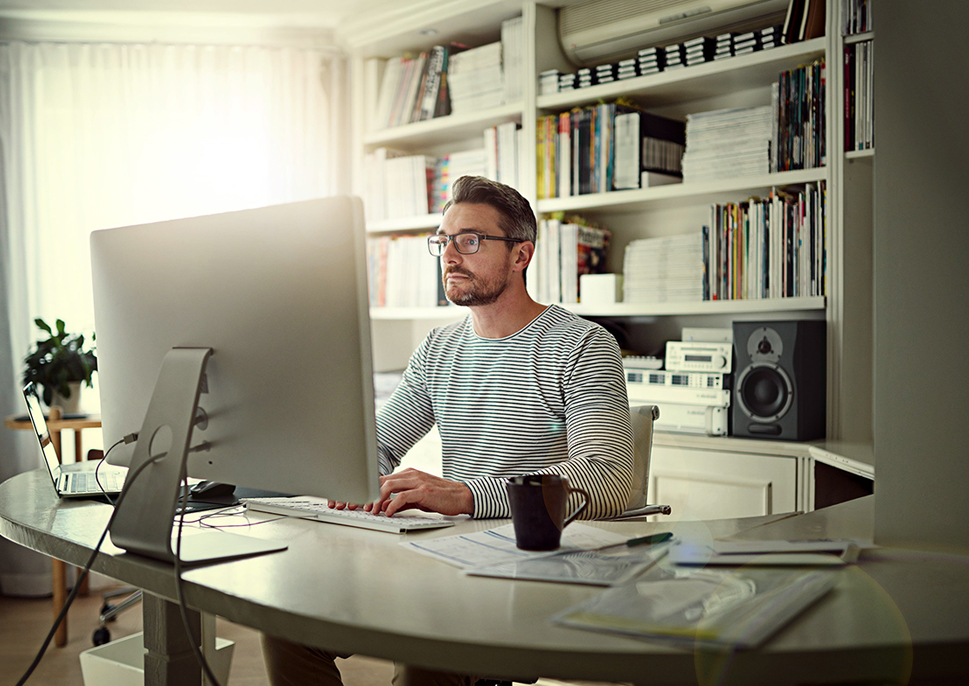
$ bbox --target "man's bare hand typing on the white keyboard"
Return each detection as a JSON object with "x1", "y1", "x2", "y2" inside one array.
[{"x1": 364, "y1": 468, "x2": 474, "y2": 517}]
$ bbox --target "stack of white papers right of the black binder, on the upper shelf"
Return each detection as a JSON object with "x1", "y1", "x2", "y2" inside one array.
[{"x1": 683, "y1": 106, "x2": 773, "y2": 182}]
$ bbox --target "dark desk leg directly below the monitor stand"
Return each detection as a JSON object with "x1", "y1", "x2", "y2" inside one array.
[{"x1": 142, "y1": 593, "x2": 202, "y2": 686}]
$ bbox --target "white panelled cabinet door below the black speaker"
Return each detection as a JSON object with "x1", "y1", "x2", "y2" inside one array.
[{"x1": 648, "y1": 446, "x2": 797, "y2": 519}]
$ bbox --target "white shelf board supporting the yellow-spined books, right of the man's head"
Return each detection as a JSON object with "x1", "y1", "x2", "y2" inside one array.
[{"x1": 537, "y1": 167, "x2": 828, "y2": 212}]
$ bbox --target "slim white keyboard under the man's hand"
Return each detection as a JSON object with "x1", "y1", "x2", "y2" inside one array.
[{"x1": 242, "y1": 497, "x2": 454, "y2": 534}]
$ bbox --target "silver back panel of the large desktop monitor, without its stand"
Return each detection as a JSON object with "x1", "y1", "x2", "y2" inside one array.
[{"x1": 91, "y1": 197, "x2": 379, "y2": 560}]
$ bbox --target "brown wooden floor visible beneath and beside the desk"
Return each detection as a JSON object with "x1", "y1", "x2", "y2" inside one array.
[{"x1": 0, "y1": 593, "x2": 393, "y2": 686}]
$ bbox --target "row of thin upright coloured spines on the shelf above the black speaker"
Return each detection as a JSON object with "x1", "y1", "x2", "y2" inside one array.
[{"x1": 700, "y1": 181, "x2": 827, "y2": 300}]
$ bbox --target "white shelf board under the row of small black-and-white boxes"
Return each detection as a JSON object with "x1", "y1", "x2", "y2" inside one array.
[{"x1": 538, "y1": 37, "x2": 825, "y2": 111}]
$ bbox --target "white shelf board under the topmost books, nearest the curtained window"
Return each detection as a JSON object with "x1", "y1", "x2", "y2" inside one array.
[{"x1": 363, "y1": 102, "x2": 522, "y2": 149}]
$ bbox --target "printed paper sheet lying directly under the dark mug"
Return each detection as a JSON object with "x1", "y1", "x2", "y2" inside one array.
[{"x1": 401, "y1": 523, "x2": 626, "y2": 569}]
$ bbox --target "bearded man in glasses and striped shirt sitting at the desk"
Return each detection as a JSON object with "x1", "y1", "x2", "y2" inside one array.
[{"x1": 263, "y1": 176, "x2": 633, "y2": 686}]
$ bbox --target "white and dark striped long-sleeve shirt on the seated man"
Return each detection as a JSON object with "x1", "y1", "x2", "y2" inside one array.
[{"x1": 377, "y1": 305, "x2": 633, "y2": 518}]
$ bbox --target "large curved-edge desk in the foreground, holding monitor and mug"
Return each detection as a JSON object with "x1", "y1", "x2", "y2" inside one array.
[{"x1": 0, "y1": 472, "x2": 969, "y2": 686}]
